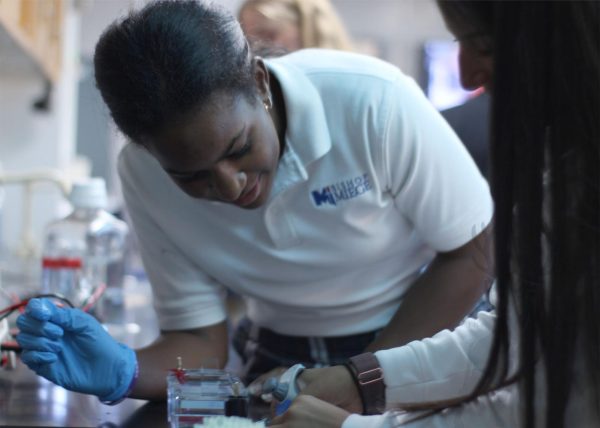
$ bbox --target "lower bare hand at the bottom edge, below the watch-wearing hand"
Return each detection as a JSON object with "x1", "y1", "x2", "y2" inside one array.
[{"x1": 269, "y1": 394, "x2": 350, "y2": 428}]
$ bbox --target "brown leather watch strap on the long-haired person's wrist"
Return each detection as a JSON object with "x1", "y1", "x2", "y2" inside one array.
[{"x1": 346, "y1": 352, "x2": 385, "y2": 415}]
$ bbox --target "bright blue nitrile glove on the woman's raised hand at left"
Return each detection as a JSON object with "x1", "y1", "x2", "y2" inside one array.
[{"x1": 17, "y1": 299, "x2": 137, "y2": 402}]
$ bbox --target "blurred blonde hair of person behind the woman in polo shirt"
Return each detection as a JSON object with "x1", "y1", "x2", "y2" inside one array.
[{"x1": 239, "y1": 0, "x2": 353, "y2": 50}]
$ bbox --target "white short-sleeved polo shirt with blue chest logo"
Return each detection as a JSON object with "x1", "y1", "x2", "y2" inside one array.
[{"x1": 119, "y1": 49, "x2": 493, "y2": 336}]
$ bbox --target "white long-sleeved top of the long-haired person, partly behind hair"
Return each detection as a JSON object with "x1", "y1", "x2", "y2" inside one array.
[{"x1": 342, "y1": 294, "x2": 600, "y2": 428}]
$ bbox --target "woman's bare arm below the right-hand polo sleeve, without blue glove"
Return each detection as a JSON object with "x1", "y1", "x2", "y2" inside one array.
[{"x1": 367, "y1": 230, "x2": 493, "y2": 351}]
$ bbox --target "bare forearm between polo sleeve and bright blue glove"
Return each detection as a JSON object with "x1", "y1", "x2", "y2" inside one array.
[{"x1": 130, "y1": 322, "x2": 227, "y2": 400}]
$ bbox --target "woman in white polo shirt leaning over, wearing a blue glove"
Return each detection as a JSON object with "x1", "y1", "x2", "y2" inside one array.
[{"x1": 15, "y1": 1, "x2": 492, "y2": 399}]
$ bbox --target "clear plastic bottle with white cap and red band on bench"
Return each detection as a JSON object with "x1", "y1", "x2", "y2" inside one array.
[{"x1": 42, "y1": 178, "x2": 129, "y2": 320}]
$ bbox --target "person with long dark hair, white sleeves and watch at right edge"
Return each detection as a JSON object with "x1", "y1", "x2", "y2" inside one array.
[{"x1": 273, "y1": 0, "x2": 600, "y2": 428}]
